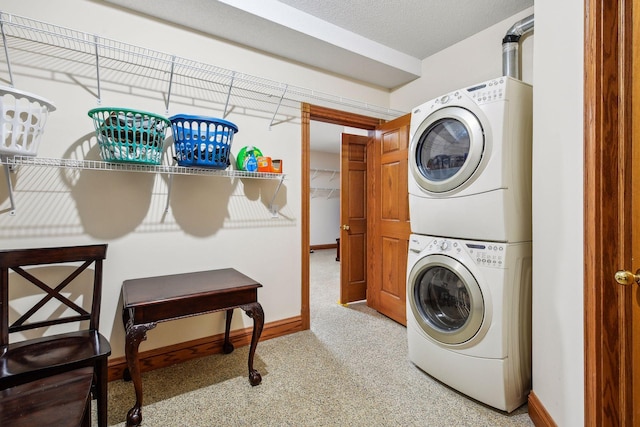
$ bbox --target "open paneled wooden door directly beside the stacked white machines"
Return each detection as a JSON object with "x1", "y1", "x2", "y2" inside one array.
[{"x1": 367, "y1": 114, "x2": 411, "y2": 325}]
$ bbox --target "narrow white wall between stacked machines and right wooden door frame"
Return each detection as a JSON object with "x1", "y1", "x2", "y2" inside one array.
[{"x1": 533, "y1": 0, "x2": 584, "y2": 426}]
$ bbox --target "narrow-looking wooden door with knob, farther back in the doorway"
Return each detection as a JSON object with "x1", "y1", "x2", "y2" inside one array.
[{"x1": 340, "y1": 134, "x2": 370, "y2": 304}]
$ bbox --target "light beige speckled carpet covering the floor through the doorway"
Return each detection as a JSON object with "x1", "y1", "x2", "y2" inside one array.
[{"x1": 94, "y1": 250, "x2": 533, "y2": 427}]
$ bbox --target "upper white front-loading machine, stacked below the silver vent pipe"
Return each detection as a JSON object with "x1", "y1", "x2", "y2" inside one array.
[{"x1": 408, "y1": 77, "x2": 532, "y2": 242}]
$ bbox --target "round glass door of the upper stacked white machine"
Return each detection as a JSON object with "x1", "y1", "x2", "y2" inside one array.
[{"x1": 409, "y1": 107, "x2": 485, "y2": 193}]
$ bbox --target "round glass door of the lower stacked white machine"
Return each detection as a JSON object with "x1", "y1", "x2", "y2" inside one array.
[{"x1": 407, "y1": 254, "x2": 484, "y2": 344}]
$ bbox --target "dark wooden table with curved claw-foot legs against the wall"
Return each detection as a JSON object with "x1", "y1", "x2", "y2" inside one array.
[{"x1": 122, "y1": 268, "x2": 264, "y2": 426}]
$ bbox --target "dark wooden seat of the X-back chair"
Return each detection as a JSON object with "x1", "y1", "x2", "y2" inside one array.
[{"x1": 0, "y1": 330, "x2": 111, "y2": 390}]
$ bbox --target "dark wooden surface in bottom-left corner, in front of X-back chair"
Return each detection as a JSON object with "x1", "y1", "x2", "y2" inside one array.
[{"x1": 0, "y1": 368, "x2": 93, "y2": 427}]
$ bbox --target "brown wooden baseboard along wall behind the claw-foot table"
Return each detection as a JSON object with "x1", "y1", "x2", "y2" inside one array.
[{"x1": 109, "y1": 316, "x2": 303, "y2": 381}]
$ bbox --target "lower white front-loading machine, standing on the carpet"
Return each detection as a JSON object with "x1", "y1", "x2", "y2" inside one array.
[{"x1": 407, "y1": 234, "x2": 531, "y2": 412}]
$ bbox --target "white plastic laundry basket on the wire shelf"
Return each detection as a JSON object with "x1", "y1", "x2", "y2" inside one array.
[{"x1": 0, "y1": 86, "x2": 56, "y2": 157}]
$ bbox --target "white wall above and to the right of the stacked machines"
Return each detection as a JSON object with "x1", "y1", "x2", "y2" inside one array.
[{"x1": 391, "y1": 4, "x2": 584, "y2": 427}]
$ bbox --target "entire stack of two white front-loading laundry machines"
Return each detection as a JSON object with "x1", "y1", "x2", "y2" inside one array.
[{"x1": 407, "y1": 76, "x2": 532, "y2": 412}]
